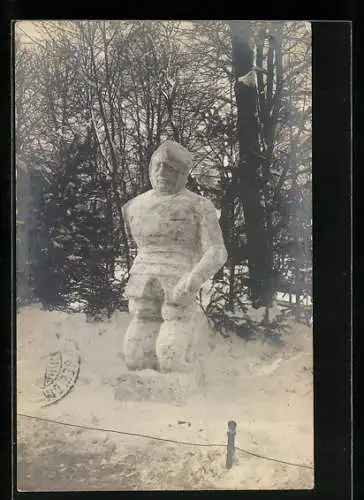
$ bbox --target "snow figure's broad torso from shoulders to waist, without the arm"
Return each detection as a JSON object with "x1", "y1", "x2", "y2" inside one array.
[{"x1": 125, "y1": 189, "x2": 206, "y2": 276}]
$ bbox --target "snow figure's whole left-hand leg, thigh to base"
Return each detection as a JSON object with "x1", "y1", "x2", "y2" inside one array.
[{"x1": 123, "y1": 280, "x2": 162, "y2": 370}]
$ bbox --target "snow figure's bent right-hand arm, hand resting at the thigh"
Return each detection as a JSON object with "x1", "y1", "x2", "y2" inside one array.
[{"x1": 174, "y1": 199, "x2": 228, "y2": 300}]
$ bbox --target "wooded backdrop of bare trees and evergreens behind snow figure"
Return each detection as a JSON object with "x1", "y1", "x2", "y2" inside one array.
[{"x1": 15, "y1": 20, "x2": 312, "y2": 329}]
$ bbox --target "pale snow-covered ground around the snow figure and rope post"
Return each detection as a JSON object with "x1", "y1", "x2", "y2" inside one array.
[{"x1": 17, "y1": 305, "x2": 313, "y2": 491}]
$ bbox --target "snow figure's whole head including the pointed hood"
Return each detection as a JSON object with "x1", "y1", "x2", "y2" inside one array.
[{"x1": 149, "y1": 141, "x2": 192, "y2": 194}]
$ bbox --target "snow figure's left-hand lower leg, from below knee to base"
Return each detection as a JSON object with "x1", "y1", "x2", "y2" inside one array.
[{"x1": 123, "y1": 317, "x2": 160, "y2": 370}]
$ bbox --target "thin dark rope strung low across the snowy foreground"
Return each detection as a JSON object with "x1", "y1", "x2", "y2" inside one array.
[{"x1": 17, "y1": 413, "x2": 313, "y2": 469}]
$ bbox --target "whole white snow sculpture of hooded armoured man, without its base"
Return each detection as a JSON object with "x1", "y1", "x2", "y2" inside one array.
[{"x1": 123, "y1": 141, "x2": 227, "y2": 371}]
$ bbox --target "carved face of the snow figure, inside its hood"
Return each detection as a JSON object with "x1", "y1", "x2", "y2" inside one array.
[{"x1": 149, "y1": 143, "x2": 189, "y2": 194}]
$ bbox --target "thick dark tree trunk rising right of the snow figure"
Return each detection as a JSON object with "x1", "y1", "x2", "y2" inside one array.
[{"x1": 230, "y1": 21, "x2": 272, "y2": 308}]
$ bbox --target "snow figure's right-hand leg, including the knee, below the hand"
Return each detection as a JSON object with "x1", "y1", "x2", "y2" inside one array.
[{"x1": 156, "y1": 303, "x2": 197, "y2": 372}]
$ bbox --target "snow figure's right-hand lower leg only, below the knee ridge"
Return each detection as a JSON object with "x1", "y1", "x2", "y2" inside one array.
[{"x1": 156, "y1": 319, "x2": 191, "y2": 371}]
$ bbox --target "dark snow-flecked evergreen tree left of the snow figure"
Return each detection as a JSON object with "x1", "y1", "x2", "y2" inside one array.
[{"x1": 34, "y1": 130, "x2": 125, "y2": 318}]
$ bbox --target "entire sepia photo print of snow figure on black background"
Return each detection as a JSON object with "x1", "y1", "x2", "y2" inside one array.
[{"x1": 13, "y1": 20, "x2": 314, "y2": 492}]
